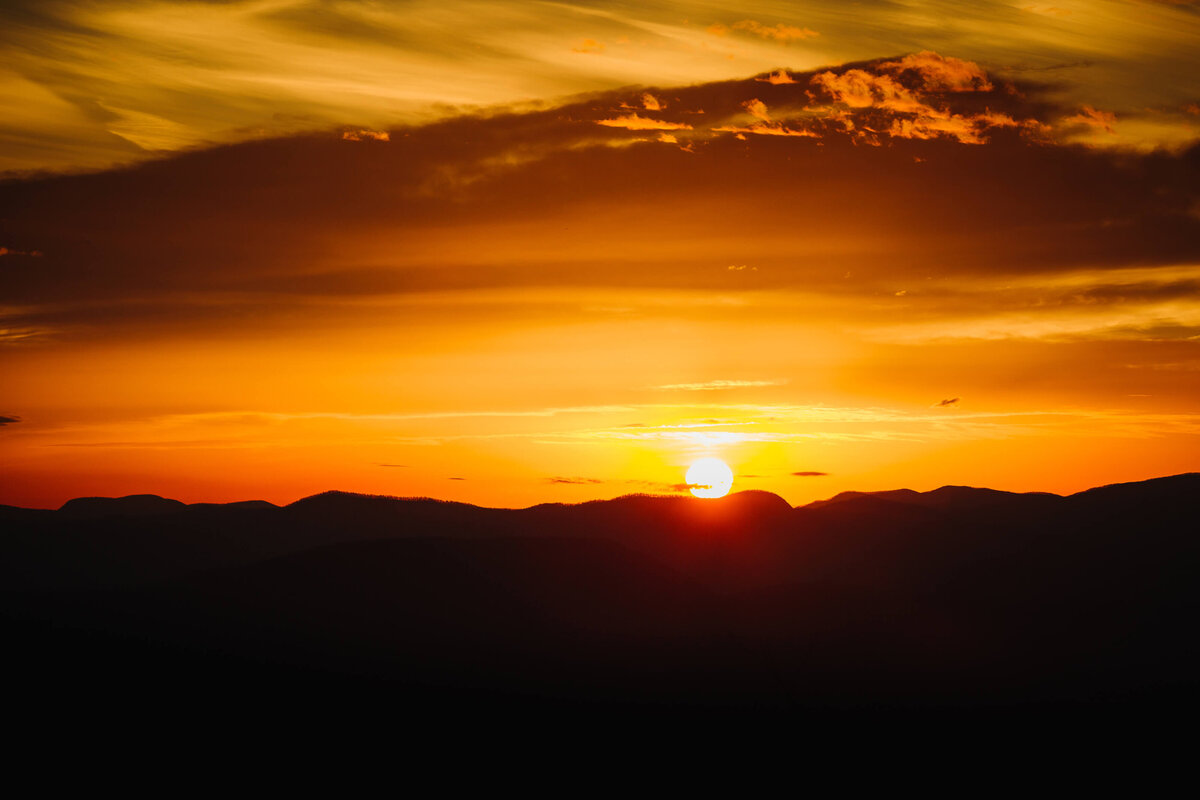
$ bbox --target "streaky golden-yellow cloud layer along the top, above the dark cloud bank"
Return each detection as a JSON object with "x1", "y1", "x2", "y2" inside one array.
[{"x1": 0, "y1": 0, "x2": 1200, "y2": 170}]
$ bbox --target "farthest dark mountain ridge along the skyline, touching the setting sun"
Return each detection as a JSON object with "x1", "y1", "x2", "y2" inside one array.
[{"x1": 0, "y1": 473, "x2": 1200, "y2": 591}]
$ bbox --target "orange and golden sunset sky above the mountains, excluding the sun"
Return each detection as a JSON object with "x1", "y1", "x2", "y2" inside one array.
[{"x1": 0, "y1": 0, "x2": 1200, "y2": 507}]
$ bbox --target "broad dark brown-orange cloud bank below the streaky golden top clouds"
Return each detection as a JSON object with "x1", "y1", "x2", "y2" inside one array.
[{"x1": 0, "y1": 59, "x2": 1200, "y2": 347}]
